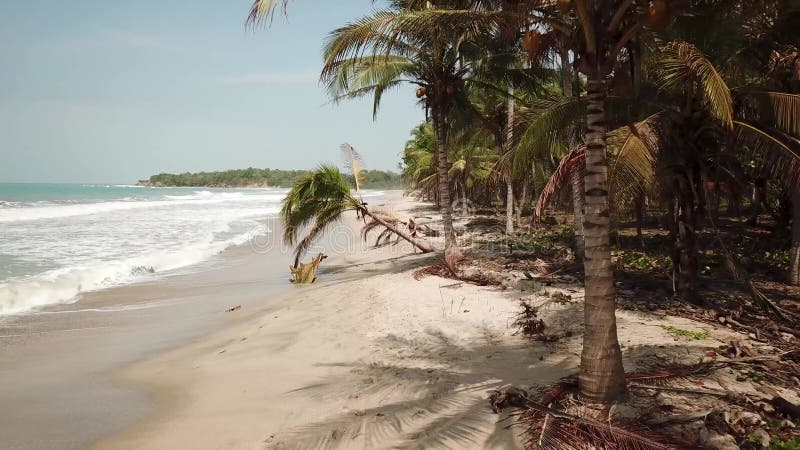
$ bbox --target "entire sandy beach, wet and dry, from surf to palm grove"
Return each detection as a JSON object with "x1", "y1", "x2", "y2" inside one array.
[{"x1": 6, "y1": 192, "x2": 788, "y2": 449}]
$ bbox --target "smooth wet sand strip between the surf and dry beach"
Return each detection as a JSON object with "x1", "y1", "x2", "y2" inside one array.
[{"x1": 0, "y1": 193, "x2": 412, "y2": 449}]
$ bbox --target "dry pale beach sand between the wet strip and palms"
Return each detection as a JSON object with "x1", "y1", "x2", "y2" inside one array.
[{"x1": 86, "y1": 192, "x2": 752, "y2": 449}]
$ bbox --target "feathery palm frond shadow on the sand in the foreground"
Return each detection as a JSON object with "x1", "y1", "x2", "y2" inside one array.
[{"x1": 267, "y1": 328, "x2": 575, "y2": 448}]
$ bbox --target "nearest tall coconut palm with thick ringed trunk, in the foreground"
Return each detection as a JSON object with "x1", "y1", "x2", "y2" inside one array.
[{"x1": 516, "y1": 0, "x2": 664, "y2": 403}]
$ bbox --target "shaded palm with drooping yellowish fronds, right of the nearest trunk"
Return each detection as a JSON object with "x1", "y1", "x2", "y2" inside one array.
[{"x1": 540, "y1": 37, "x2": 800, "y2": 301}]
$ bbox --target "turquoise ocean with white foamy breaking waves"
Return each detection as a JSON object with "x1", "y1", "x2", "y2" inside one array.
[{"x1": 0, "y1": 183, "x2": 286, "y2": 316}]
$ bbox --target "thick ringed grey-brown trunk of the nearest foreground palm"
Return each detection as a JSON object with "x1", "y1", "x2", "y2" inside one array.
[{"x1": 579, "y1": 75, "x2": 626, "y2": 404}]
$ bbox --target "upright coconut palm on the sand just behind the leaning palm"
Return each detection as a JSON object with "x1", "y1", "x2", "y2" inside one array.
[{"x1": 321, "y1": 0, "x2": 504, "y2": 261}]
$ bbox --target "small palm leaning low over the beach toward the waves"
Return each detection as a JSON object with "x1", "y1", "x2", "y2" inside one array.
[{"x1": 281, "y1": 164, "x2": 433, "y2": 268}]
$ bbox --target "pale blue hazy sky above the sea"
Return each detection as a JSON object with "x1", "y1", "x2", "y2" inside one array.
[{"x1": 0, "y1": 0, "x2": 424, "y2": 183}]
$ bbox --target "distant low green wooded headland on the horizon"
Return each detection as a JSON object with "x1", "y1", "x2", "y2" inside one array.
[{"x1": 139, "y1": 167, "x2": 403, "y2": 189}]
